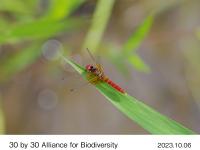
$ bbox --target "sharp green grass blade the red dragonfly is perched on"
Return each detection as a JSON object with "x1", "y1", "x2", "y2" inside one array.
[{"x1": 62, "y1": 56, "x2": 195, "y2": 134}]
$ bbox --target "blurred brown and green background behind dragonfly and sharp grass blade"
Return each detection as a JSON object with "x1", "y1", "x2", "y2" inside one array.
[{"x1": 0, "y1": 0, "x2": 200, "y2": 134}]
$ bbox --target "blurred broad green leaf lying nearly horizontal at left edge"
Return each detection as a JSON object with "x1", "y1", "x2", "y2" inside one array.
[{"x1": 0, "y1": 18, "x2": 83, "y2": 44}]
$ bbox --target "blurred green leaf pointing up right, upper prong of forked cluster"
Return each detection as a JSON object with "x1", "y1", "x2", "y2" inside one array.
[{"x1": 123, "y1": 15, "x2": 154, "y2": 55}]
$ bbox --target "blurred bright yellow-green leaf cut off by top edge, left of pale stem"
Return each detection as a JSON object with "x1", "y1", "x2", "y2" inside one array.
[{"x1": 46, "y1": 0, "x2": 85, "y2": 20}]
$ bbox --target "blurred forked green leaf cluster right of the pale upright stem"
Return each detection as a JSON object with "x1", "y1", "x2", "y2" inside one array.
[{"x1": 107, "y1": 15, "x2": 154, "y2": 76}]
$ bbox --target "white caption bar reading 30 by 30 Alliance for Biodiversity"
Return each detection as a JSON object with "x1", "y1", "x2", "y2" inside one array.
[{"x1": 0, "y1": 135, "x2": 200, "y2": 150}]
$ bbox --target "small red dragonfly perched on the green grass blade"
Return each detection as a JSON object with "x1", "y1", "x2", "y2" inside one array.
[{"x1": 85, "y1": 49, "x2": 125, "y2": 94}]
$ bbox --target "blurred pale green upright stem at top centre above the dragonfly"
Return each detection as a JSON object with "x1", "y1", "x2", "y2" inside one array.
[{"x1": 83, "y1": 0, "x2": 115, "y2": 53}]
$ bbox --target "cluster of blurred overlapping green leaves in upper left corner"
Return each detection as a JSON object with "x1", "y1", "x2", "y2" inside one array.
[{"x1": 0, "y1": 0, "x2": 84, "y2": 81}]
